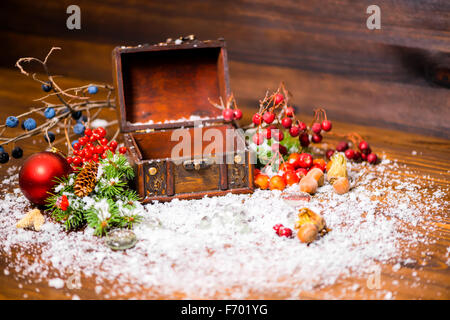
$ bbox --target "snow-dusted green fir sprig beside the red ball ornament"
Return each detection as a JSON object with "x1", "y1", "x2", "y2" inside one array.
[{"x1": 47, "y1": 152, "x2": 143, "y2": 236}]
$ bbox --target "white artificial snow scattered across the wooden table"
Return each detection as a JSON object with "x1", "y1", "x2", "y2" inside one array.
[{"x1": 0, "y1": 159, "x2": 450, "y2": 299}]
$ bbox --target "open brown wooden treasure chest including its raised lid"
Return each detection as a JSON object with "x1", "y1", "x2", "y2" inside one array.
[{"x1": 113, "y1": 39, "x2": 253, "y2": 203}]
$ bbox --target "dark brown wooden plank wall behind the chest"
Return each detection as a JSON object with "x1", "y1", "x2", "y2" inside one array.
[{"x1": 0, "y1": 0, "x2": 450, "y2": 138}]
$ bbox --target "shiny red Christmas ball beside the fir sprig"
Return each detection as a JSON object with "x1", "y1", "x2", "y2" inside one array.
[{"x1": 19, "y1": 151, "x2": 72, "y2": 205}]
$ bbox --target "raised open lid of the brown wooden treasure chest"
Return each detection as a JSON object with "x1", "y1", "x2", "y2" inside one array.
[{"x1": 113, "y1": 39, "x2": 229, "y2": 132}]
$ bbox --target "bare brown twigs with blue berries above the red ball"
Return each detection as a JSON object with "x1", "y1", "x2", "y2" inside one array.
[{"x1": 0, "y1": 47, "x2": 115, "y2": 163}]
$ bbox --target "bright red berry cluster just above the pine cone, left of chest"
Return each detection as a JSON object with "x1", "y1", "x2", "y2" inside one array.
[{"x1": 66, "y1": 127, "x2": 127, "y2": 167}]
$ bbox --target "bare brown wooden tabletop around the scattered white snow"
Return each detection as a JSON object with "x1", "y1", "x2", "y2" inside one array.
[{"x1": 0, "y1": 69, "x2": 450, "y2": 299}]
